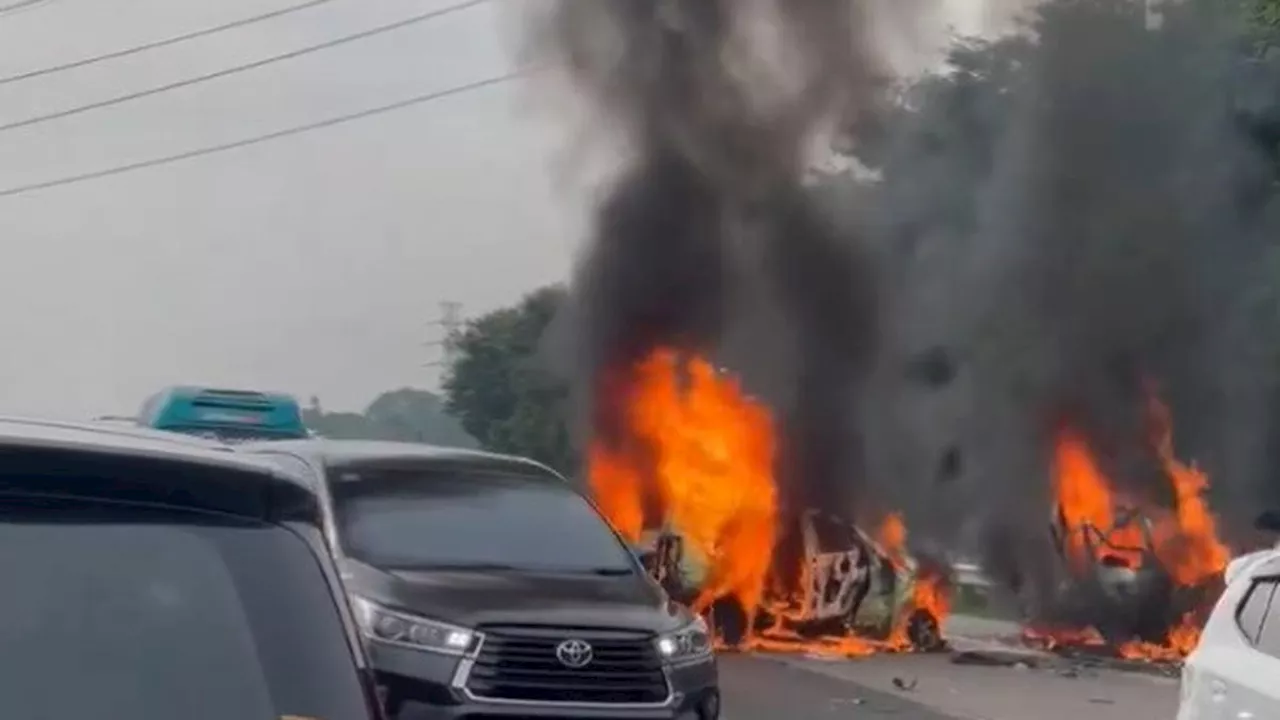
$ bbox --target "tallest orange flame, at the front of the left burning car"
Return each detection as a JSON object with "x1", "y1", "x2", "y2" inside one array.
[{"x1": 588, "y1": 350, "x2": 777, "y2": 618}]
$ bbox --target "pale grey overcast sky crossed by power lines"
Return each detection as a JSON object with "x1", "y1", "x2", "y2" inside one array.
[{"x1": 0, "y1": 0, "x2": 1008, "y2": 418}]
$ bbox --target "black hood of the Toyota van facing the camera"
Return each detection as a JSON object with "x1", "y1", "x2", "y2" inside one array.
[{"x1": 340, "y1": 559, "x2": 694, "y2": 633}]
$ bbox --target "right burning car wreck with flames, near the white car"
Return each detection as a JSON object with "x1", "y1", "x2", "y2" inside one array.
[{"x1": 1027, "y1": 398, "x2": 1230, "y2": 661}]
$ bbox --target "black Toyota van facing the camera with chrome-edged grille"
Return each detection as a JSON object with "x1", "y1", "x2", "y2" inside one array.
[{"x1": 238, "y1": 438, "x2": 719, "y2": 720}]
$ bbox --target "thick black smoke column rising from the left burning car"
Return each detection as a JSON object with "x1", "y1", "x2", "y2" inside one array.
[{"x1": 524, "y1": 0, "x2": 896, "y2": 509}]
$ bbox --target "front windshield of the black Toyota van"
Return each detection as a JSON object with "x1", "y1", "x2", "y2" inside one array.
[{"x1": 330, "y1": 468, "x2": 636, "y2": 575}]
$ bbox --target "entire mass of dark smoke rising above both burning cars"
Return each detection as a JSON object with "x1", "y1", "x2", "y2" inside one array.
[{"x1": 536, "y1": 0, "x2": 1280, "y2": 625}]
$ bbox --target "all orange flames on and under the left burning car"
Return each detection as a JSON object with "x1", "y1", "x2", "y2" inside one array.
[{"x1": 588, "y1": 348, "x2": 950, "y2": 657}]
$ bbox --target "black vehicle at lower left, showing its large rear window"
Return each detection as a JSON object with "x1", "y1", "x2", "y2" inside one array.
[{"x1": 0, "y1": 419, "x2": 380, "y2": 720}]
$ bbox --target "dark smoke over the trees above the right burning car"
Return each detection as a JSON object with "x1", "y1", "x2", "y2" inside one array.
[{"x1": 869, "y1": 0, "x2": 1280, "y2": 620}]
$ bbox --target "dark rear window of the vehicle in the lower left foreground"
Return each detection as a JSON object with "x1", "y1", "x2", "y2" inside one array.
[{"x1": 0, "y1": 498, "x2": 367, "y2": 720}]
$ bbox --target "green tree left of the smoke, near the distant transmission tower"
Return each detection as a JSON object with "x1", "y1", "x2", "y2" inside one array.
[{"x1": 444, "y1": 286, "x2": 575, "y2": 473}]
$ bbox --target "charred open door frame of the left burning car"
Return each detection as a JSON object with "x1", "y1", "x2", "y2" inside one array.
[{"x1": 801, "y1": 511, "x2": 869, "y2": 620}]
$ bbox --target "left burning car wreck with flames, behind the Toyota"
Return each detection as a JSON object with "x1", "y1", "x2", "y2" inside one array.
[{"x1": 589, "y1": 351, "x2": 950, "y2": 655}]
